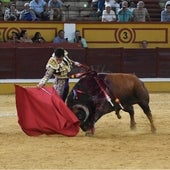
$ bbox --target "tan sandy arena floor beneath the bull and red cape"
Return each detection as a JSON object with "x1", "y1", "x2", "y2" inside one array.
[{"x1": 0, "y1": 93, "x2": 170, "y2": 170}]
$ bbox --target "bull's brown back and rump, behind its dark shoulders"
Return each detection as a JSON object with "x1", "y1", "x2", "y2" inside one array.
[{"x1": 100, "y1": 73, "x2": 149, "y2": 100}]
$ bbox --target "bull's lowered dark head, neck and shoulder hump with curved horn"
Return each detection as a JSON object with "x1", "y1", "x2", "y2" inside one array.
[{"x1": 67, "y1": 70, "x2": 109, "y2": 131}]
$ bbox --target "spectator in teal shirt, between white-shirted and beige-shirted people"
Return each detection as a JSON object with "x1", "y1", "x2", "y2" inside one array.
[{"x1": 118, "y1": 1, "x2": 132, "y2": 22}]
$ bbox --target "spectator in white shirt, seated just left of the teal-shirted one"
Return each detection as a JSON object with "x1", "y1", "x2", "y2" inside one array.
[{"x1": 102, "y1": 4, "x2": 116, "y2": 22}]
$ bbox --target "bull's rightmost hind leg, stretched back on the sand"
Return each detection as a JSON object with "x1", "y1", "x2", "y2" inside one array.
[{"x1": 139, "y1": 104, "x2": 156, "y2": 133}]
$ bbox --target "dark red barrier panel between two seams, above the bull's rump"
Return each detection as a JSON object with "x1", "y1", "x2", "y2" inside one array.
[{"x1": 122, "y1": 49, "x2": 157, "y2": 77}]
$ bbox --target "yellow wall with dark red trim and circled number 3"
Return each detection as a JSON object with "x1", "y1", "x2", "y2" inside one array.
[{"x1": 0, "y1": 21, "x2": 170, "y2": 48}]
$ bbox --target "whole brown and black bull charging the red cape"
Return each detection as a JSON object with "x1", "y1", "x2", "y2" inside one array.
[{"x1": 67, "y1": 71, "x2": 156, "y2": 133}]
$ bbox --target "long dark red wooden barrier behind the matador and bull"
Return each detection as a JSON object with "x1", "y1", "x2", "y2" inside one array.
[{"x1": 0, "y1": 43, "x2": 170, "y2": 79}]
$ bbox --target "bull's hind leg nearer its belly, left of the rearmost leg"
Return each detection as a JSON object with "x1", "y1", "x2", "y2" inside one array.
[{"x1": 124, "y1": 106, "x2": 136, "y2": 129}]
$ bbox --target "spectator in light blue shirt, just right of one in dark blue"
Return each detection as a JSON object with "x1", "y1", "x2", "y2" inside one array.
[{"x1": 30, "y1": 0, "x2": 49, "y2": 21}]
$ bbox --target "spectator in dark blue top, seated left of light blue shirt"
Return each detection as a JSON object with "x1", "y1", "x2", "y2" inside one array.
[{"x1": 19, "y1": 3, "x2": 37, "y2": 21}]
